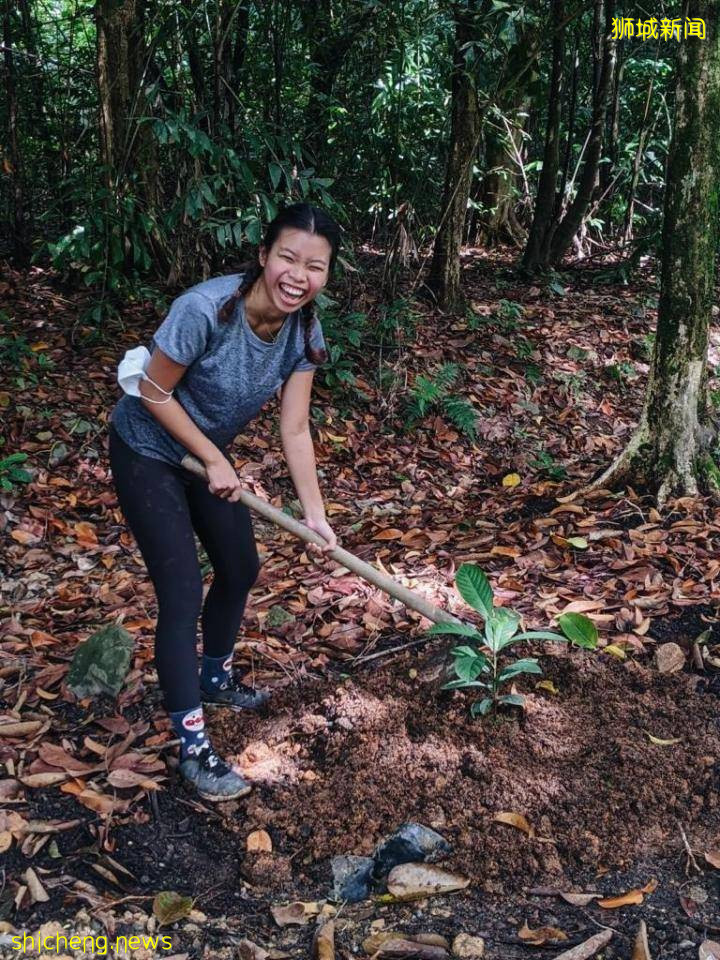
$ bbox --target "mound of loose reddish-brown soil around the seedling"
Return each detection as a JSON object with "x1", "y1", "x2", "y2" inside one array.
[{"x1": 214, "y1": 651, "x2": 720, "y2": 892}]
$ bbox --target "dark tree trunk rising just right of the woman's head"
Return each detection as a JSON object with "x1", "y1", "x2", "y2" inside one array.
[{"x1": 427, "y1": 0, "x2": 480, "y2": 310}]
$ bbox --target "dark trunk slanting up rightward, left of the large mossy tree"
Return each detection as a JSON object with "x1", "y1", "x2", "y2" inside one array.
[{"x1": 549, "y1": 0, "x2": 615, "y2": 264}]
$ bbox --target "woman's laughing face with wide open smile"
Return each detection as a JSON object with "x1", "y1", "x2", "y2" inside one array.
[{"x1": 259, "y1": 227, "x2": 332, "y2": 315}]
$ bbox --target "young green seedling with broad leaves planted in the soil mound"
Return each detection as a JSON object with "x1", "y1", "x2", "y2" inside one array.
[{"x1": 428, "y1": 563, "x2": 597, "y2": 717}]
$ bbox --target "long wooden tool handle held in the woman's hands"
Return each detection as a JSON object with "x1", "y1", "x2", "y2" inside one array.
[{"x1": 182, "y1": 453, "x2": 461, "y2": 623}]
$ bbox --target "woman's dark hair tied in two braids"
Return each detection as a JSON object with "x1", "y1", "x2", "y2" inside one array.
[{"x1": 218, "y1": 203, "x2": 340, "y2": 365}]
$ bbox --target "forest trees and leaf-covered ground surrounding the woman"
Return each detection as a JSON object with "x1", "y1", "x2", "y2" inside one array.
[{"x1": 0, "y1": 0, "x2": 720, "y2": 958}]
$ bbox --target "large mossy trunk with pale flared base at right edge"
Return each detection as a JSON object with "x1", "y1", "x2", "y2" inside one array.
[{"x1": 588, "y1": 0, "x2": 720, "y2": 504}]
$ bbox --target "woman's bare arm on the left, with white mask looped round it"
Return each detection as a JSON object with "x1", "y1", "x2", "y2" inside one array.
[{"x1": 139, "y1": 347, "x2": 241, "y2": 501}]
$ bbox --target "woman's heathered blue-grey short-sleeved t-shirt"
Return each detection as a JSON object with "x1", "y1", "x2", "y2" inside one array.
[{"x1": 111, "y1": 274, "x2": 325, "y2": 465}]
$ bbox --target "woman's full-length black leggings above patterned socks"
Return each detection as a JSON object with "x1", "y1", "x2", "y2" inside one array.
[{"x1": 109, "y1": 425, "x2": 260, "y2": 711}]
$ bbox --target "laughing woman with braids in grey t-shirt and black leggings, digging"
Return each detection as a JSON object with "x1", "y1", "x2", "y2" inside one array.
[{"x1": 110, "y1": 203, "x2": 340, "y2": 801}]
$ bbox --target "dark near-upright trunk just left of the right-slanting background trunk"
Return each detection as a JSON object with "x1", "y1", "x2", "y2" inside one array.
[{"x1": 521, "y1": 0, "x2": 565, "y2": 272}]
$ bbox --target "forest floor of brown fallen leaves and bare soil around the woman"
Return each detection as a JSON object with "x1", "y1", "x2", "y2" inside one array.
[{"x1": 0, "y1": 252, "x2": 720, "y2": 960}]
